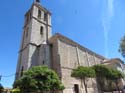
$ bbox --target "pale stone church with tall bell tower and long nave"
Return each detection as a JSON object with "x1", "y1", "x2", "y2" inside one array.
[{"x1": 16, "y1": 0, "x2": 124, "y2": 93}]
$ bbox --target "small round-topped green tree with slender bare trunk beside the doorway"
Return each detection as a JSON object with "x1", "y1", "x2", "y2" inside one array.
[{"x1": 71, "y1": 66, "x2": 95, "y2": 93}]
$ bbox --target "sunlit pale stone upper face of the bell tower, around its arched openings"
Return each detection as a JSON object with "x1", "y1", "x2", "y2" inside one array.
[{"x1": 30, "y1": 6, "x2": 52, "y2": 45}]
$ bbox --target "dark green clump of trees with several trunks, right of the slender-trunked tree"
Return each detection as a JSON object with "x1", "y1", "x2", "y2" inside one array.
[{"x1": 93, "y1": 65, "x2": 123, "y2": 90}]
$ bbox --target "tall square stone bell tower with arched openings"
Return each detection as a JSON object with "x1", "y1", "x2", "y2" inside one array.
[{"x1": 16, "y1": 0, "x2": 51, "y2": 79}]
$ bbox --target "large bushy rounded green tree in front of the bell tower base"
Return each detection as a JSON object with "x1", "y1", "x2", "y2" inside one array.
[{"x1": 14, "y1": 66, "x2": 64, "y2": 93}]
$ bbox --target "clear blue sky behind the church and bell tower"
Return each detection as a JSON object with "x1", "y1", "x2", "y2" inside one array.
[{"x1": 0, "y1": 0, "x2": 125, "y2": 87}]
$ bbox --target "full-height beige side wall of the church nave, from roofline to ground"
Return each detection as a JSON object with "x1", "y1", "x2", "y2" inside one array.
[{"x1": 57, "y1": 39, "x2": 104, "y2": 93}]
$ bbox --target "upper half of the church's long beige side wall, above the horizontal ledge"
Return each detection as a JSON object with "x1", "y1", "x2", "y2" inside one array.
[{"x1": 58, "y1": 39, "x2": 104, "y2": 68}]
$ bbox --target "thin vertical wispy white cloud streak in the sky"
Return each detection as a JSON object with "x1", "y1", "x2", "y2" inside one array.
[{"x1": 102, "y1": 0, "x2": 114, "y2": 57}]
